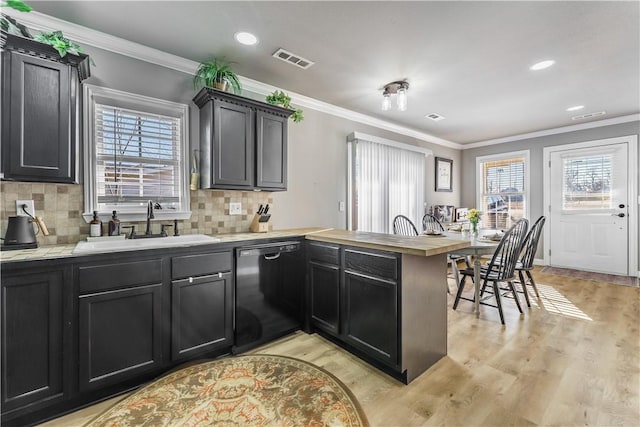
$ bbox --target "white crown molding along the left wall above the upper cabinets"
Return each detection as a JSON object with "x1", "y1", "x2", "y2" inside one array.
[{"x1": 3, "y1": 10, "x2": 464, "y2": 150}]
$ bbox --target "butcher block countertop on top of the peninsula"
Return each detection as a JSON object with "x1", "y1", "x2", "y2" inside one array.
[{"x1": 306, "y1": 230, "x2": 470, "y2": 256}]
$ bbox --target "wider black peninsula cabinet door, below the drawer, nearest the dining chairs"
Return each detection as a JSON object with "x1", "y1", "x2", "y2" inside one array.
[{"x1": 342, "y1": 271, "x2": 398, "y2": 367}]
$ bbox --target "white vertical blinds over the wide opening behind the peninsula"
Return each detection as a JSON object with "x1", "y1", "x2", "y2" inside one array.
[{"x1": 348, "y1": 133, "x2": 431, "y2": 233}]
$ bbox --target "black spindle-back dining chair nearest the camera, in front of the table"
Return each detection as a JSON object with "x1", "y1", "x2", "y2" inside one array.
[{"x1": 453, "y1": 218, "x2": 529, "y2": 325}]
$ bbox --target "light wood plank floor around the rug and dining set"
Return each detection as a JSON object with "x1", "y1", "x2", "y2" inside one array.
[{"x1": 40, "y1": 270, "x2": 640, "y2": 427}]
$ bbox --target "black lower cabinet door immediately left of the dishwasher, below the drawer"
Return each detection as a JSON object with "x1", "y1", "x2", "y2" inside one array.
[{"x1": 171, "y1": 272, "x2": 233, "y2": 360}]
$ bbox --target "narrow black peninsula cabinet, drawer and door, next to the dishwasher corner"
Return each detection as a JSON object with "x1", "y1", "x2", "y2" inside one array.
[{"x1": 307, "y1": 242, "x2": 341, "y2": 336}]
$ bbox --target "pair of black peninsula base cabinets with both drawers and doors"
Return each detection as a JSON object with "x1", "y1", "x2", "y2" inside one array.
[{"x1": 307, "y1": 242, "x2": 400, "y2": 370}]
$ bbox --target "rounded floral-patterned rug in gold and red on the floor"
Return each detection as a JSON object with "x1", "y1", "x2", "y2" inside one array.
[{"x1": 86, "y1": 355, "x2": 369, "y2": 427}]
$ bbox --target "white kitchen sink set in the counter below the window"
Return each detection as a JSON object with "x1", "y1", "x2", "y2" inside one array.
[{"x1": 72, "y1": 234, "x2": 220, "y2": 254}]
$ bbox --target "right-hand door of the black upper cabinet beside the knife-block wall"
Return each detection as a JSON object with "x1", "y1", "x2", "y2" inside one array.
[{"x1": 256, "y1": 110, "x2": 287, "y2": 190}]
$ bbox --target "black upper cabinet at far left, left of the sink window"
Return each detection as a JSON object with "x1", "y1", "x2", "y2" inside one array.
[{"x1": 0, "y1": 32, "x2": 90, "y2": 183}]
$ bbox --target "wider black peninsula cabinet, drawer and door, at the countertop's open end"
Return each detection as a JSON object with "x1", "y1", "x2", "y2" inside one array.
[{"x1": 342, "y1": 248, "x2": 399, "y2": 367}]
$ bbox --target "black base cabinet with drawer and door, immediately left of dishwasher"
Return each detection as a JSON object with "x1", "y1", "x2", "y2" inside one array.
[{"x1": 171, "y1": 251, "x2": 234, "y2": 360}]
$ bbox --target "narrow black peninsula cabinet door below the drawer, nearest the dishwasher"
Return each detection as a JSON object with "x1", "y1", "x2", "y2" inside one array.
[{"x1": 309, "y1": 261, "x2": 340, "y2": 335}]
